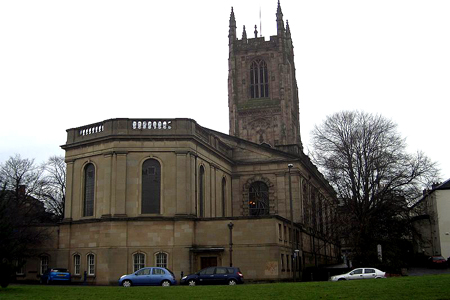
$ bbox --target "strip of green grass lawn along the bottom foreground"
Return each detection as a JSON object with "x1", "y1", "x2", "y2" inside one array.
[{"x1": 0, "y1": 275, "x2": 450, "y2": 300}]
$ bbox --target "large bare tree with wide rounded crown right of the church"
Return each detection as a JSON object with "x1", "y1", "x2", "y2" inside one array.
[{"x1": 312, "y1": 111, "x2": 438, "y2": 261}]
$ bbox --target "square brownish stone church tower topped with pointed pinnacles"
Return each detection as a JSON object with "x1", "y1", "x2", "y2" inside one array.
[{"x1": 228, "y1": 1, "x2": 302, "y2": 149}]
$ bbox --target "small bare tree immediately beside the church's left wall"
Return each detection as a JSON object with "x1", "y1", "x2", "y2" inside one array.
[{"x1": 39, "y1": 156, "x2": 66, "y2": 220}]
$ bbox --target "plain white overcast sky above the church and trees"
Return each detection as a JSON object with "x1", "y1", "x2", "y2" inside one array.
[{"x1": 0, "y1": 0, "x2": 450, "y2": 180}]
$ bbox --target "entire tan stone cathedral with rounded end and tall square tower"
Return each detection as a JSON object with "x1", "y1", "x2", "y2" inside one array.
[{"x1": 20, "y1": 2, "x2": 340, "y2": 284}]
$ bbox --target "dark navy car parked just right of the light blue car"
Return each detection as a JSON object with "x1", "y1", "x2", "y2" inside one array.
[{"x1": 180, "y1": 267, "x2": 244, "y2": 286}]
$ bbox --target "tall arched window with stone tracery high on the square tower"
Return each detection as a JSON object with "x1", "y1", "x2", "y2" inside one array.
[{"x1": 250, "y1": 59, "x2": 269, "y2": 98}]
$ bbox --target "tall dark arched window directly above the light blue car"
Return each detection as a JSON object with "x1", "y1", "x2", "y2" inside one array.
[{"x1": 142, "y1": 159, "x2": 161, "y2": 214}]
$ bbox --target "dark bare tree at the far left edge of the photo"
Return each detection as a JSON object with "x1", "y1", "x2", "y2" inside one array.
[{"x1": 0, "y1": 155, "x2": 52, "y2": 287}]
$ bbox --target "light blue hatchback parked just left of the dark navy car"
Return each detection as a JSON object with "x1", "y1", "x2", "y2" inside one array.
[{"x1": 119, "y1": 267, "x2": 177, "y2": 287}]
